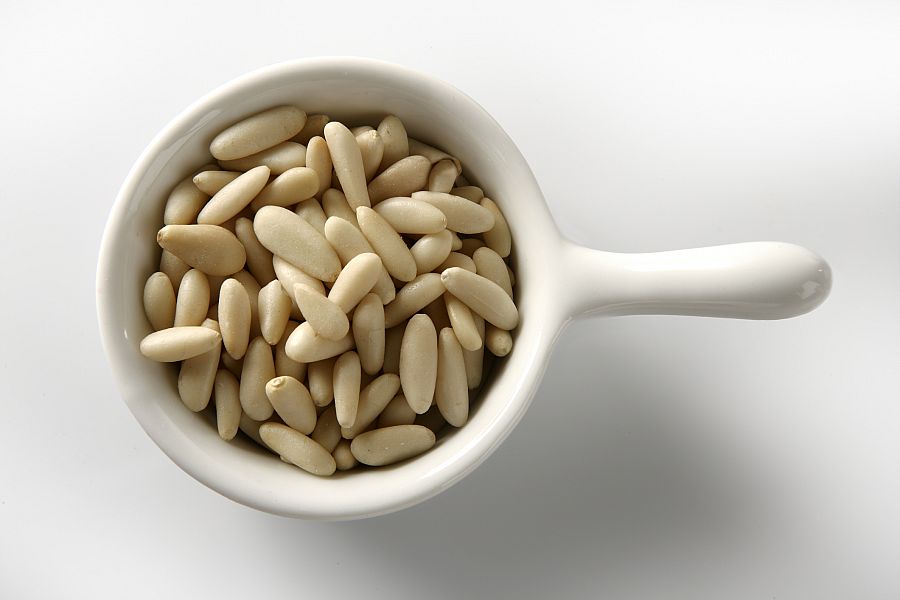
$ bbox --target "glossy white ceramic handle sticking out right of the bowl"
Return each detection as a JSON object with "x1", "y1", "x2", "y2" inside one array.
[{"x1": 560, "y1": 242, "x2": 831, "y2": 319}]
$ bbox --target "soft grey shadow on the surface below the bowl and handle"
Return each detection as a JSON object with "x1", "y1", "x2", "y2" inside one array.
[{"x1": 253, "y1": 322, "x2": 767, "y2": 597}]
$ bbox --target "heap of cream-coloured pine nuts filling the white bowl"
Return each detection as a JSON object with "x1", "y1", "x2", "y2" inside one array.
[{"x1": 140, "y1": 106, "x2": 519, "y2": 475}]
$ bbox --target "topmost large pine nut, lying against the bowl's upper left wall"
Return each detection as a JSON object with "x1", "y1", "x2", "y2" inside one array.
[{"x1": 209, "y1": 106, "x2": 306, "y2": 161}]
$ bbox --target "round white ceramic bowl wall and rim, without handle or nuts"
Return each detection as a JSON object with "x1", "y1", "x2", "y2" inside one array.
[{"x1": 109, "y1": 62, "x2": 558, "y2": 518}]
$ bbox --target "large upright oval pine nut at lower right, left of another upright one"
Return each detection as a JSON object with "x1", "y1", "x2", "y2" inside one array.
[{"x1": 400, "y1": 315, "x2": 438, "y2": 414}]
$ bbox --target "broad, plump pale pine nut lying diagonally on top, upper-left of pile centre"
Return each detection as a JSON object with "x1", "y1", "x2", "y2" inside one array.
[{"x1": 253, "y1": 206, "x2": 341, "y2": 281}]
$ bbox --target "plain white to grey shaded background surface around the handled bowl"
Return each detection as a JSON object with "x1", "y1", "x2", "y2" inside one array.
[{"x1": 0, "y1": 0, "x2": 900, "y2": 600}]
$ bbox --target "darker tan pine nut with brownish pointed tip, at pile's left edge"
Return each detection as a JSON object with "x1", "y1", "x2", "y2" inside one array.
[{"x1": 156, "y1": 225, "x2": 247, "y2": 276}]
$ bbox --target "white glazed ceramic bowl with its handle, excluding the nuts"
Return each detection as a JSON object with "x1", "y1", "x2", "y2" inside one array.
[{"x1": 97, "y1": 58, "x2": 831, "y2": 519}]
